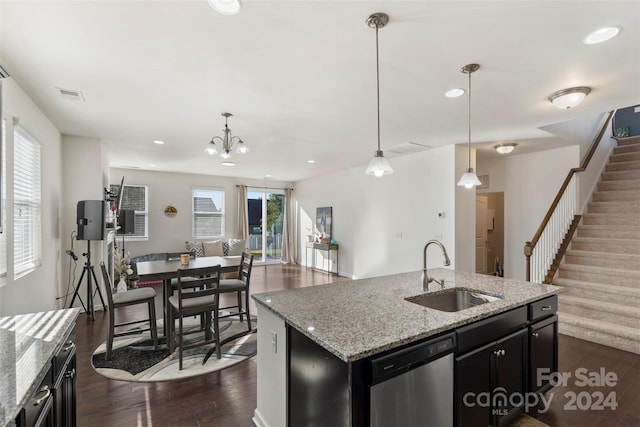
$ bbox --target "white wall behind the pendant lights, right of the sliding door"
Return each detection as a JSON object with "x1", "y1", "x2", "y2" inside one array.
[{"x1": 295, "y1": 145, "x2": 475, "y2": 278}]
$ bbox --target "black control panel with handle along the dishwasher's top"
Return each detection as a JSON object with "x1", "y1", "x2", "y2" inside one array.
[{"x1": 371, "y1": 333, "x2": 456, "y2": 385}]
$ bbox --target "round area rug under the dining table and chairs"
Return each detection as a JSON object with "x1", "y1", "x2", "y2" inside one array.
[{"x1": 91, "y1": 316, "x2": 257, "y2": 382}]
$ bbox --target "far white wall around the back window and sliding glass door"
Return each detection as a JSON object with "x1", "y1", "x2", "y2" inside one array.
[{"x1": 110, "y1": 168, "x2": 292, "y2": 256}]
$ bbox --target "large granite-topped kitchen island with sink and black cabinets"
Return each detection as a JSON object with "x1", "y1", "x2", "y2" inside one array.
[{"x1": 253, "y1": 268, "x2": 561, "y2": 427}]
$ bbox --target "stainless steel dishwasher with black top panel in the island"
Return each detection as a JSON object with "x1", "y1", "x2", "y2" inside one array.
[{"x1": 370, "y1": 333, "x2": 455, "y2": 427}]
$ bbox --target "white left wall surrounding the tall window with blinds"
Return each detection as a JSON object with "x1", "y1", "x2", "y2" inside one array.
[{"x1": 0, "y1": 78, "x2": 63, "y2": 316}]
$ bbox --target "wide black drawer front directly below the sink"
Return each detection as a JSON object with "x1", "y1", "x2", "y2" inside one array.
[{"x1": 456, "y1": 306, "x2": 527, "y2": 354}]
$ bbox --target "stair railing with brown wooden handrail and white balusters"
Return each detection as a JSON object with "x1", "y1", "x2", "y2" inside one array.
[{"x1": 524, "y1": 111, "x2": 615, "y2": 283}]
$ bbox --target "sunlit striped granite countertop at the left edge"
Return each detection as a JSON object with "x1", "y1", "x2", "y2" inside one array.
[{"x1": 0, "y1": 308, "x2": 80, "y2": 426}]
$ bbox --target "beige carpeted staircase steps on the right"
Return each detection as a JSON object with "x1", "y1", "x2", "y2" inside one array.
[{"x1": 552, "y1": 137, "x2": 640, "y2": 354}]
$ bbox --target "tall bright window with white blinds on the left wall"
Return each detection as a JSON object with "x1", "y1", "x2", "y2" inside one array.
[{"x1": 13, "y1": 126, "x2": 42, "y2": 277}]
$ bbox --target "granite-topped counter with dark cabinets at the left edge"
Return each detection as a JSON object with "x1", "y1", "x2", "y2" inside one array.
[{"x1": 0, "y1": 308, "x2": 80, "y2": 427}]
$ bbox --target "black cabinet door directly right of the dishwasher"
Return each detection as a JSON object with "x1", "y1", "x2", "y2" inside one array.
[{"x1": 454, "y1": 343, "x2": 494, "y2": 427}]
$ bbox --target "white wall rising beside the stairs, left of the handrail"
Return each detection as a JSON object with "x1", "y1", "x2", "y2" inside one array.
[{"x1": 478, "y1": 145, "x2": 580, "y2": 280}]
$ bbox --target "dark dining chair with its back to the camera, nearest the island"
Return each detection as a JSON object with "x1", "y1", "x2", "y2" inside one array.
[{"x1": 168, "y1": 265, "x2": 221, "y2": 370}]
